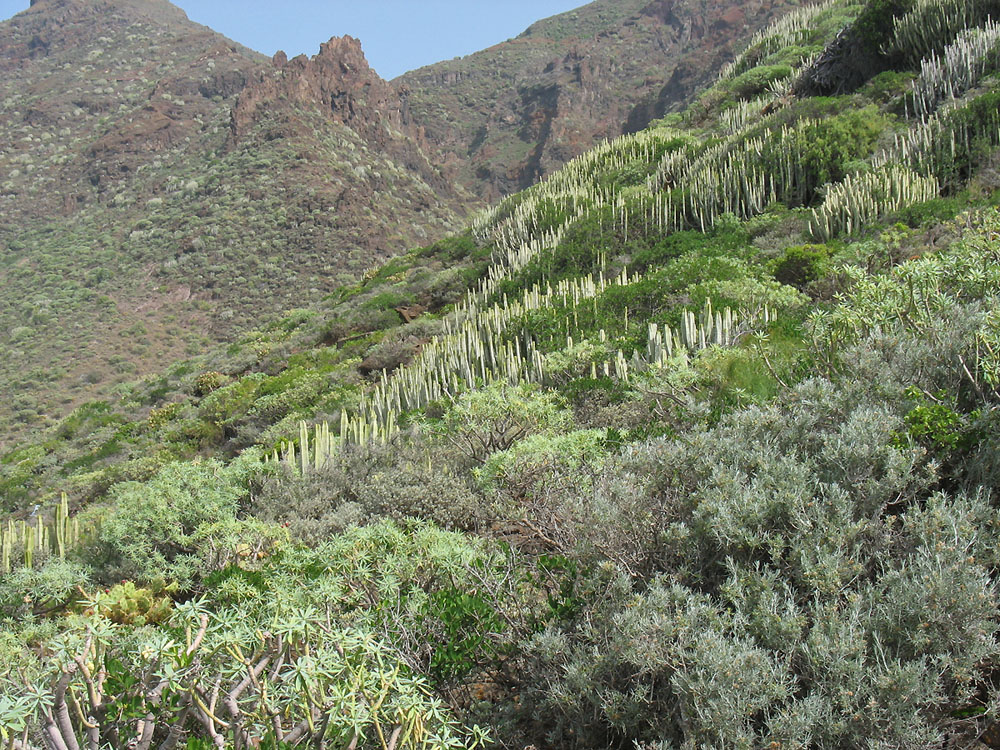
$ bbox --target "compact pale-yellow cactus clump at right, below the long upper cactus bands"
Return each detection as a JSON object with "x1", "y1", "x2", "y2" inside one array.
[{"x1": 809, "y1": 164, "x2": 941, "y2": 242}]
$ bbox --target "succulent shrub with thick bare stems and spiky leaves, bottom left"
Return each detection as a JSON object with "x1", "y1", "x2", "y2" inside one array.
[{"x1": 5, "y1": 602, "x2": 487, "y2": 748}]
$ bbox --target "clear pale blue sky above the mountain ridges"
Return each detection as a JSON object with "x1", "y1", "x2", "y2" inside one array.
[{"x1": 0, "y1": 0, "x2": 586, "y2": 78}]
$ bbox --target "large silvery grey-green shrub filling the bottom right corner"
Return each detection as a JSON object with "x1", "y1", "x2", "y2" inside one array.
[{"x1": 523, "y1": 382, "x2": 997, "y2": 747}]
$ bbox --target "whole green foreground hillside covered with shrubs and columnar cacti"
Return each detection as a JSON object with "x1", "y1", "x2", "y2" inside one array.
[{"x1": 0, "y1": 0, "x2": 1000, "y2": 750}]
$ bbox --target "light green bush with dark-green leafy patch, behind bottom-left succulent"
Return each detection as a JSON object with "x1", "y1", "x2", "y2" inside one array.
[{"x1": 203, "y1": 521, "x2": 548, "y2": 688}]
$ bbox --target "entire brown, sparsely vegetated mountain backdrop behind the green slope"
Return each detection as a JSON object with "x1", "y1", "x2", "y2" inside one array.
[{"x1": 0, "y1": 0, "x2": 804, "y2": 440}]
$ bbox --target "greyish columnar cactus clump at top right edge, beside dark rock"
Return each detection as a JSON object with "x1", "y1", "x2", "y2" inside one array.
[{"x1": 911, "y1": 19, "x2": 1000, "y2": 120}]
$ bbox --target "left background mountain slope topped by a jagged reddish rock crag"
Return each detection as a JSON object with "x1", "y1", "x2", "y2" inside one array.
[{"x1": 0, "y1": 0, "x2": 475, "y2": 438}]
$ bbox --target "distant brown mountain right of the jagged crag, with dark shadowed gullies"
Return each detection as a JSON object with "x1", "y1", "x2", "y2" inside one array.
[{"x1": 397, "y1": 0, "x2": 820, "y2": 199}]
